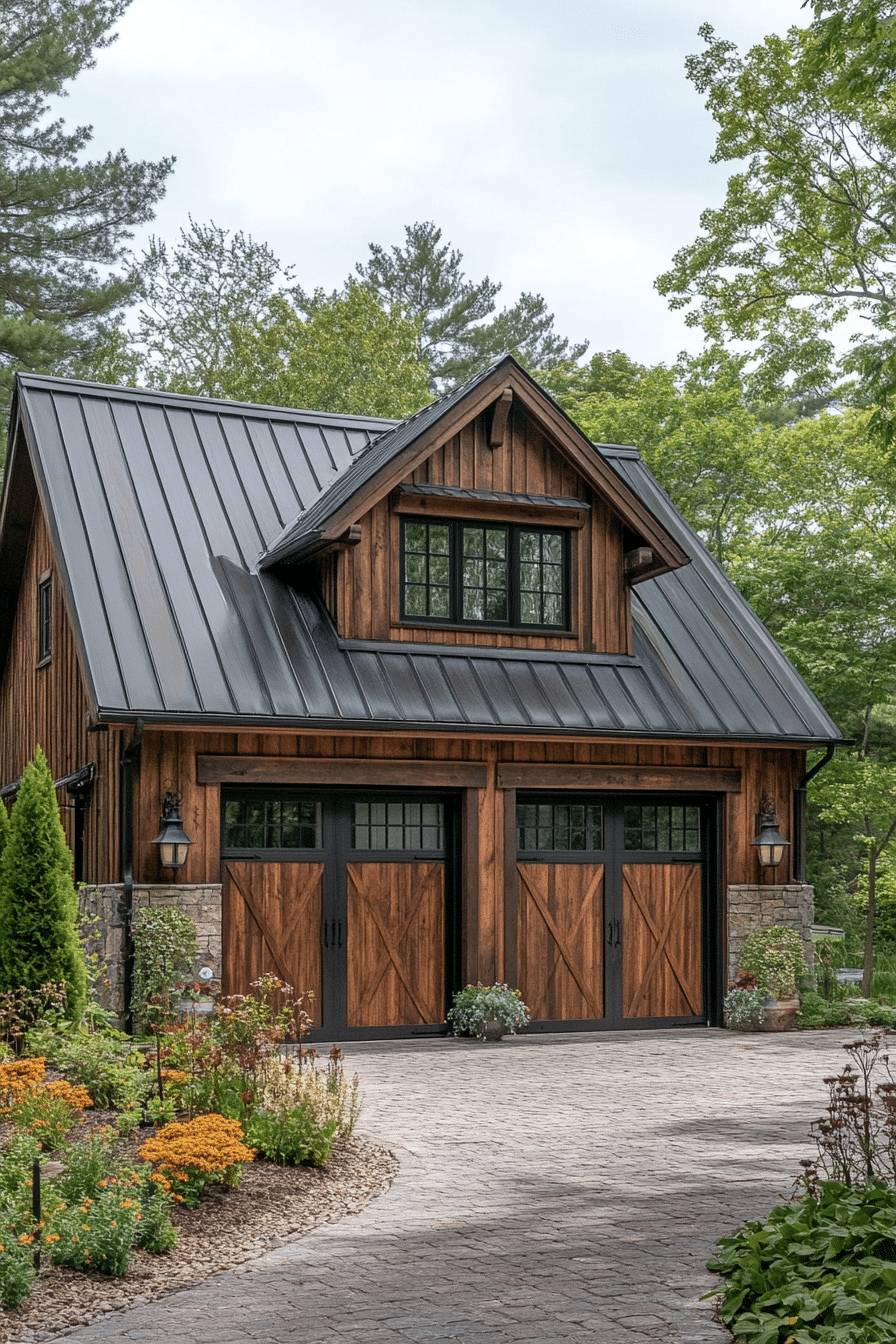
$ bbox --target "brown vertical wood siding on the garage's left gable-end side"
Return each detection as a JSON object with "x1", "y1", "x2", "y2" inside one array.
[{"x1": 0, "y1": 507, "x2": 120, "y2": 882}]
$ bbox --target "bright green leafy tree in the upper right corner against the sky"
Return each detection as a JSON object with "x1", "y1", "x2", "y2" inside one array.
[{"x1": 657, "y1": 0, "x2": 896, "y2": 422}]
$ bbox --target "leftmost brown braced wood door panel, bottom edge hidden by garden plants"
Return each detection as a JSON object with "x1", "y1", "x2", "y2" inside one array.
[{"x1": 223, "y1": 859, "x2": 324, "y2": 1003}]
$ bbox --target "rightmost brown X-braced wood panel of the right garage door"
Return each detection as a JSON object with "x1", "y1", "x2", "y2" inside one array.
[{"x1": 622, "y1": 863, "x2": 703, "y2": 1017}]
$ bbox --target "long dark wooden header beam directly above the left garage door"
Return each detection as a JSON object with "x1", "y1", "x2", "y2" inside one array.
[{"x1": 196, "y1": 755, "x2": 488, "y2": 789}]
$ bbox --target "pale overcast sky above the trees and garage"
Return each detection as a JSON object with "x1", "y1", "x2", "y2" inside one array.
[{"x1": 62, "y1": 0, "x2": 807, "y2": 362}]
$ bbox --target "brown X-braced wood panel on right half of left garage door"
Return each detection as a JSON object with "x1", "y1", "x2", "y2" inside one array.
[{"x1": 347, "y1": 860, "x2": 445, "y2": 1027}]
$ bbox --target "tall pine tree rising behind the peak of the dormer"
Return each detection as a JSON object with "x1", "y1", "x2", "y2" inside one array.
[{"x1": 355, "y1": 222, "x2": 587, "y2": 392}]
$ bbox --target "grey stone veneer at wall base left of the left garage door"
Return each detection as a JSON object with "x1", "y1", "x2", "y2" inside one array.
[{"x1": 78, "y1": 883, "x2": 222, "y2": 1016}]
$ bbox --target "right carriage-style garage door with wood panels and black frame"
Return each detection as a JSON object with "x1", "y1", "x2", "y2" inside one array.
[{"x1": 516, "y1": 794, "x2": 711, "y2": 1030}]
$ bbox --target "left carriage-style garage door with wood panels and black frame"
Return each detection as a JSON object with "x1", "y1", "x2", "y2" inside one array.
[{"x1": 222, "y1": 789, "x2": 459, "y2": 1036}]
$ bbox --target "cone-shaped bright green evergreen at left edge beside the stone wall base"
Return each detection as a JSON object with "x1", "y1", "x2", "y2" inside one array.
[{"x1": 0, "y1": 747, "x2": 87, "y2": 1021}]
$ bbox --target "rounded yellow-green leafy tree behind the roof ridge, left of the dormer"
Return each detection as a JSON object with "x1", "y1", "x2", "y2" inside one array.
[{"x1": 222, "y1": 282, "x2": 431, "y2": 419}]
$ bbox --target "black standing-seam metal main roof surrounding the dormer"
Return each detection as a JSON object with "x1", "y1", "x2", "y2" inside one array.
[{"x1": 0, "y1": 376, "x2": 841, "y2": 743}]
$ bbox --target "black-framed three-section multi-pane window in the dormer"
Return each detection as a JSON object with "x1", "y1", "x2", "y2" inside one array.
[{"x1": 402, "y1": 519, "x2": 570, "y2": 629}]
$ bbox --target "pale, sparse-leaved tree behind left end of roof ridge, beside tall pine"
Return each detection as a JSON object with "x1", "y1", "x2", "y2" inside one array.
[{"x1": 137, "y1": 219, "x2": 292, "y2": 396}]
